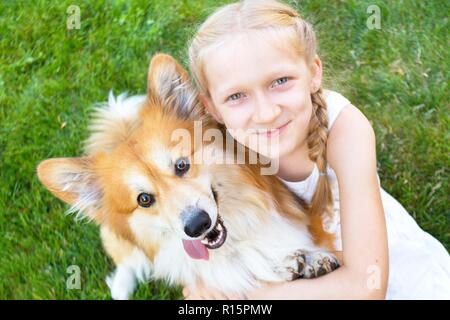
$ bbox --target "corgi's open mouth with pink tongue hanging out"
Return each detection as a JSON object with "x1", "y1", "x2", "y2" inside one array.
[{"x1": 182, "y1": 216, "x2": 227, "y2": 260}]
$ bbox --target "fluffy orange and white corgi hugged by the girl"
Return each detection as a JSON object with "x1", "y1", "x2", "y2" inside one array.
[{"x1": 37, "y1": 54, "x2": 339, "y2": 299}]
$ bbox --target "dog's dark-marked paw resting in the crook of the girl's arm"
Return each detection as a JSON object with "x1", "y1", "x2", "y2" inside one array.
[{"x1": 303, "y1": 252, "x2": 339, "y2": 279}]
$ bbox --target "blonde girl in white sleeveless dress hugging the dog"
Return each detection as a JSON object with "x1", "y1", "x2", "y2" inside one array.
[{"x1": 183, "y1": 0, "x2": 450, "y2": 299}]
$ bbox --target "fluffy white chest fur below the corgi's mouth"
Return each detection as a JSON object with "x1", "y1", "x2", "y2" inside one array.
[{"x1": 154, "y1": 206, "x2": 320, "y2": 294}]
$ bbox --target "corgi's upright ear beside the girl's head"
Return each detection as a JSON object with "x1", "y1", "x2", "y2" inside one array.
[{"x1": 147, "y1": 53, "x2": 204, "y2": 119}]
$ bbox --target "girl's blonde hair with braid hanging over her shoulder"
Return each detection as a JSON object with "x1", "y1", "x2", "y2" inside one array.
[{"x1": 189, "y1": 0, "x2": 332, "y2": 224}]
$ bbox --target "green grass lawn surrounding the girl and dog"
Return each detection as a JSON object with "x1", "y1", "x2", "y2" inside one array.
[{"x1": 0, "y1": 0, "x2": 450, "y2": 299}]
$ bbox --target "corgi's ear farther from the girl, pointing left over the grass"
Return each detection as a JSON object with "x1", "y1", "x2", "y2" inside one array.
[{"x1": 37, "y1": 157, "x2": 101, "y2": 219}]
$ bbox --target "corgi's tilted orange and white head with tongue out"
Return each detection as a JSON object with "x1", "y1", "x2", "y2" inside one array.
[{"x1": 37, "y1": 54, "x2": 232, "y2": 259}]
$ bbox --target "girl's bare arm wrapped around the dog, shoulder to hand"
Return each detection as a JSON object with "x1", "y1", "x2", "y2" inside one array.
[{"x1": 184, "y1": 105, "x2": 388, "y2": 299}]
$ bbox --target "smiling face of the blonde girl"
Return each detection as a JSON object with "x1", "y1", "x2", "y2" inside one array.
[{"x1": 202, "y1": 34, "x2": 322, "y2": 158}]
